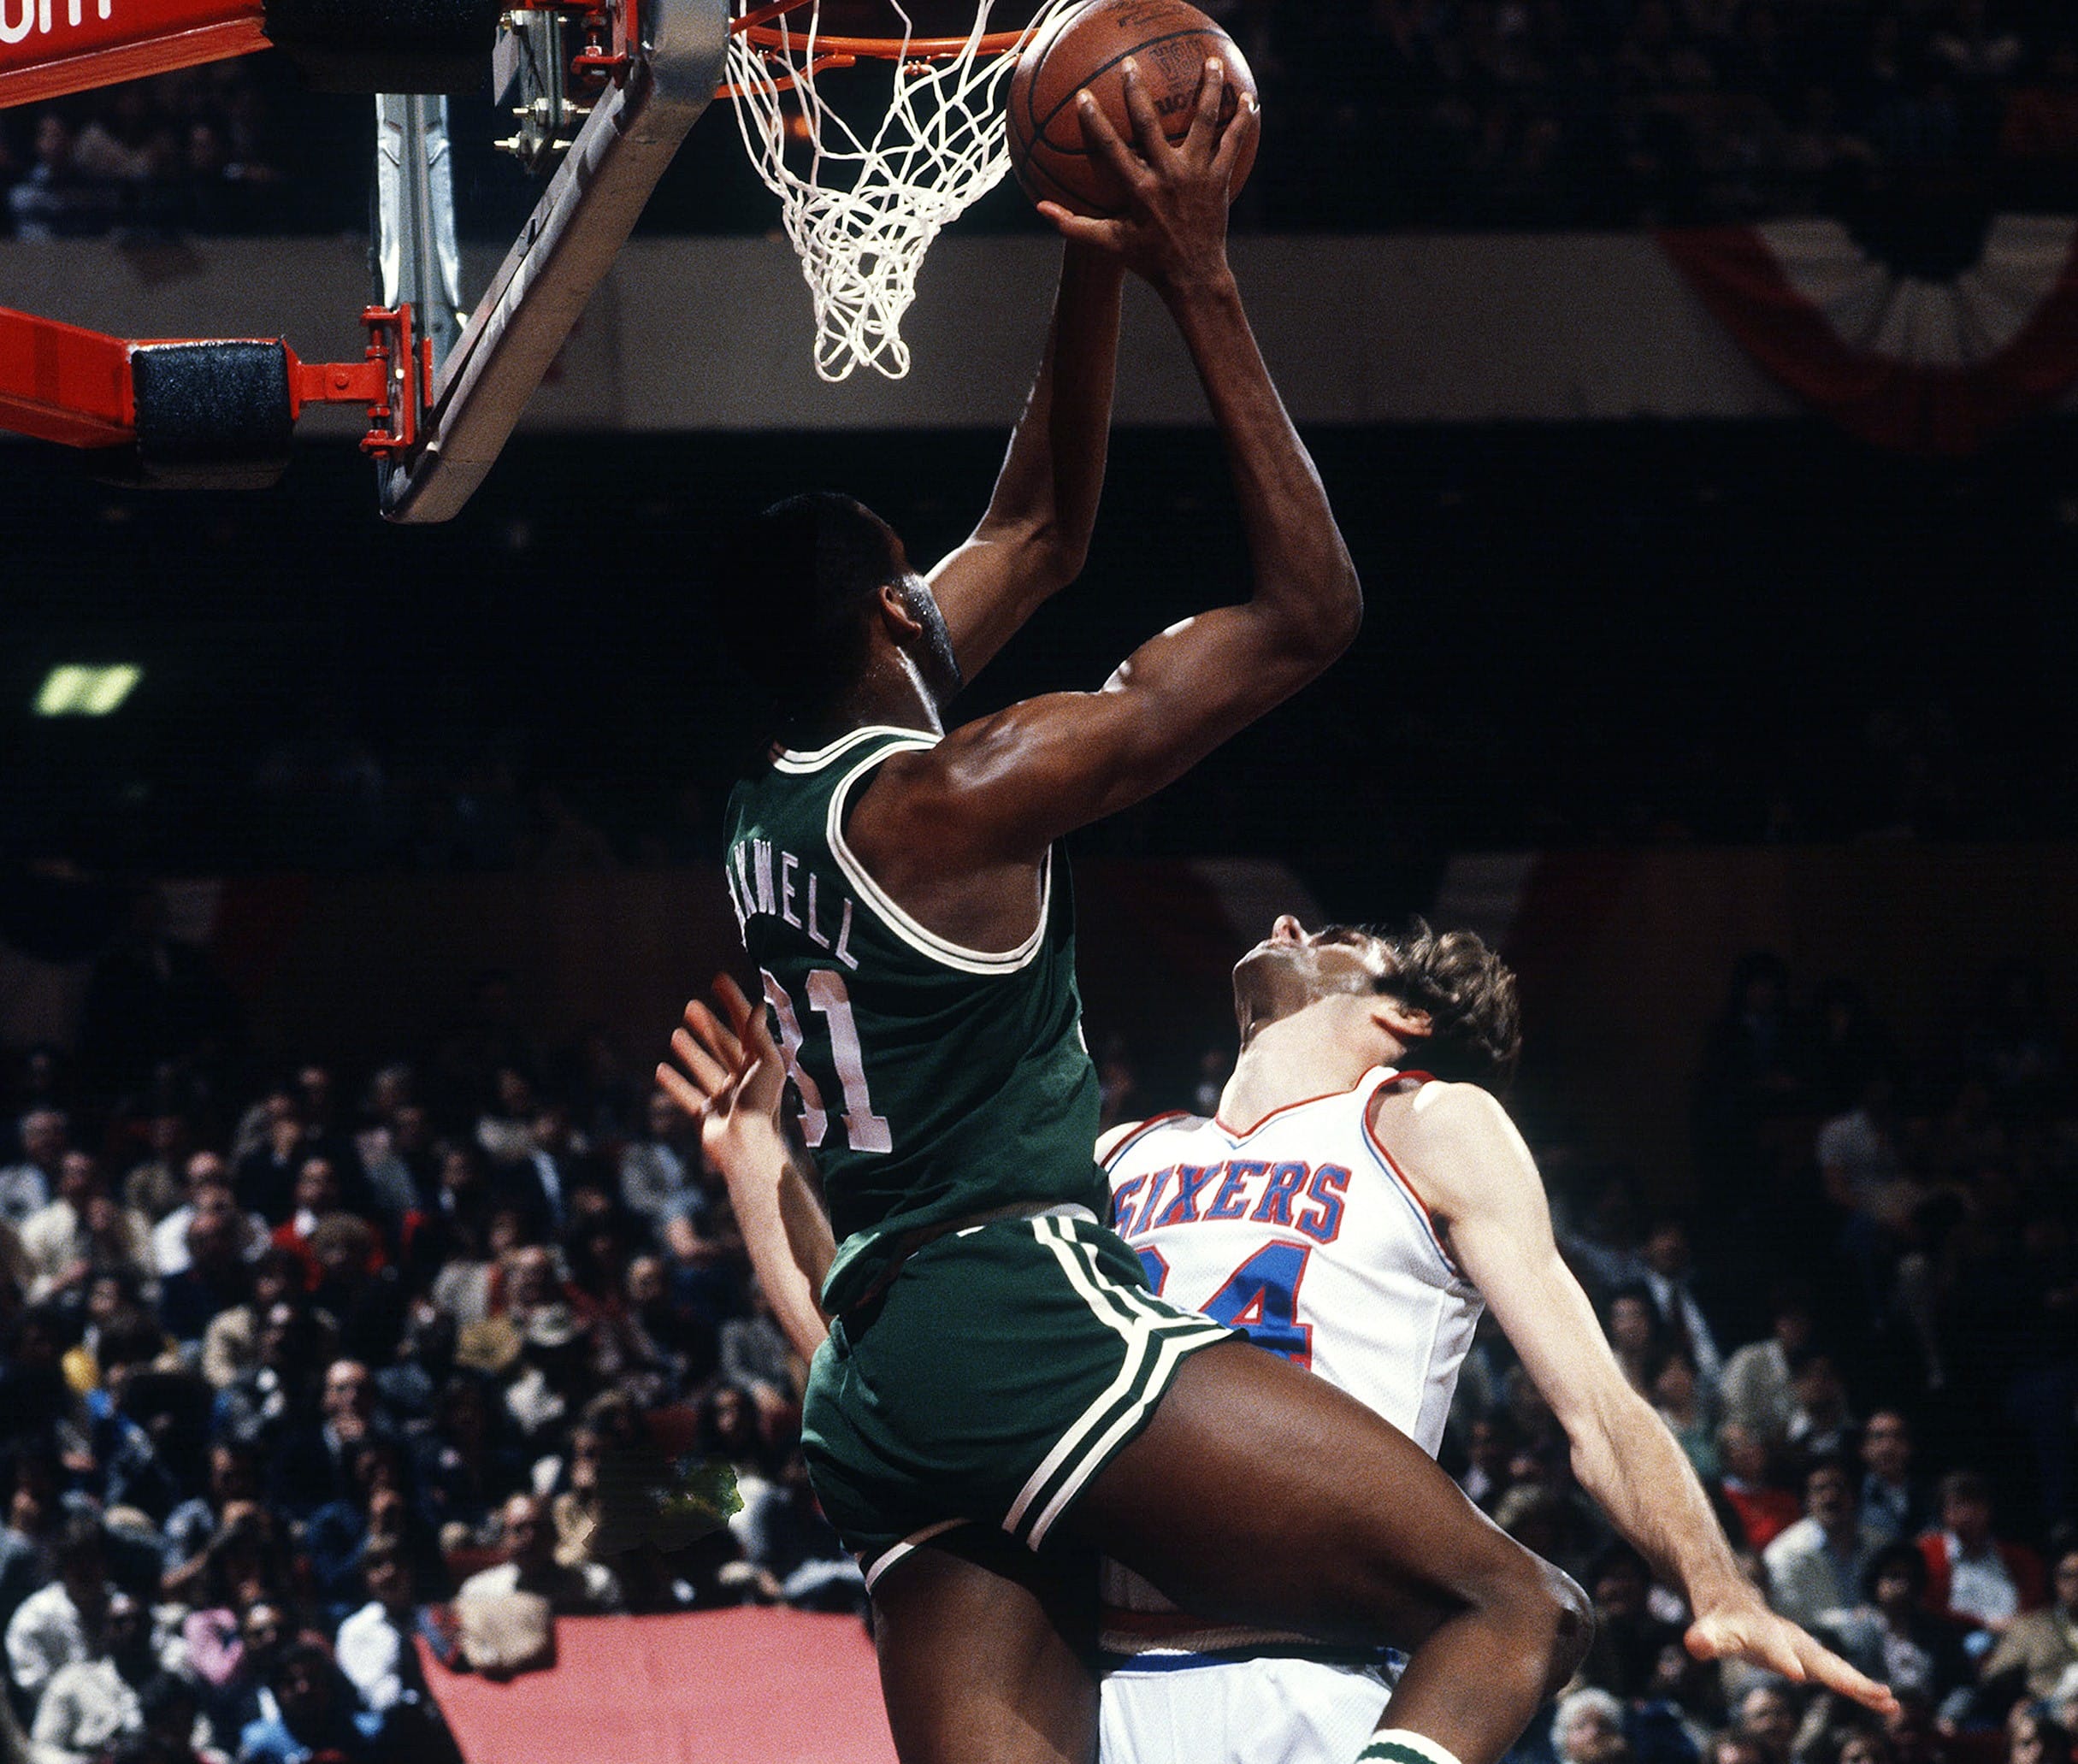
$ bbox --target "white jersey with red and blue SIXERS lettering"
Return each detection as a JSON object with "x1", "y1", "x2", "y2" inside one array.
[{"x1": 1106, "y1": 1066, "x2": 1484, "y2": 1654}]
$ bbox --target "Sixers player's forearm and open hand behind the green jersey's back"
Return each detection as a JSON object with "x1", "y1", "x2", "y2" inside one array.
[{"x1": 657, "y1": 975, "x2": 837, "y2": 1359}]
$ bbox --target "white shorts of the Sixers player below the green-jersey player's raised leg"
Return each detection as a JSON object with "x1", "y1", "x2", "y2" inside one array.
[{"x1": 1097, "y1": 1661, "x2": 1388, "y2": 1764}]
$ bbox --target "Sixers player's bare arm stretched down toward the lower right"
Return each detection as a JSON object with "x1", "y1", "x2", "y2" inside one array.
[{"x1": 1373, "y1": 1084, "x2": 1891, "y2": 1710}]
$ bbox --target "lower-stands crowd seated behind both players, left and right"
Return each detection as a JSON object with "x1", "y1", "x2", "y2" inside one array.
[{"x1": 0, "y1": 922, "x2": 2078, "y2": 1764}]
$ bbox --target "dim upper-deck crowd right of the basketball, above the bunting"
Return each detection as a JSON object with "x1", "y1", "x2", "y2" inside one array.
[{"x1": 1228, "y1": 0, "x2": 2078, "y2": 228}]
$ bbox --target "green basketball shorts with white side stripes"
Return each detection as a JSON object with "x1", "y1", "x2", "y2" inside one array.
[{"x1": 802, "y1": 1207, "x2": 1241, "y2": 1587}]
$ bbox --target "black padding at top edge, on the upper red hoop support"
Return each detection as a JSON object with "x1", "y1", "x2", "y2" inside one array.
[{"x1": 266, "y1": 0, "x2": 505, "y2": 91}]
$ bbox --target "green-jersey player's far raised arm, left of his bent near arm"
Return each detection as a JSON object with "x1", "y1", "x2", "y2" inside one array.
[{"x1": 929, "y1": 241, "x2": 1125, "y2": 680}]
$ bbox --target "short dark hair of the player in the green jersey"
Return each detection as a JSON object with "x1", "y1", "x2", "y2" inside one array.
[{"x1": 712, "y1": 490, "x2": 902, "y2": 715}]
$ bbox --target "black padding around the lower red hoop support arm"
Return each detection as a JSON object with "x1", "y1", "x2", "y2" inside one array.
[{"x1": 131, "y1": 343, "x2": 295, "y2": 490}]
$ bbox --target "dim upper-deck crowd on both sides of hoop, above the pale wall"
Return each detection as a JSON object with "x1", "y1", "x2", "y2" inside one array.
[{"x1": 0, "y1": 0, "x2": 2078, "y2": 237}]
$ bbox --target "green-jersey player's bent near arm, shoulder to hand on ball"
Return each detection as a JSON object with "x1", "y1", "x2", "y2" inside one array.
[{"x1": 854, "y1": 62, "x2": 1363, "y2": 872}]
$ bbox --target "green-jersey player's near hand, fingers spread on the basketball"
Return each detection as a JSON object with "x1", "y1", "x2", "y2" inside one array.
[{"x1": 1039, "y1": 56, "x2": 1261, "y2": 293}]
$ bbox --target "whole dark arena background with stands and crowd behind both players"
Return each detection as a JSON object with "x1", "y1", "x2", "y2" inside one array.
[{"x1": 0, "y1": 0, "x2": 2078, "y2": 1764}]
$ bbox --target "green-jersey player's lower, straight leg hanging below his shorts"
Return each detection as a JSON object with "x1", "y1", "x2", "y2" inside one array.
[{"x1": 873, "y1": 1525, "x2": 1097, "y2": 1764}]
